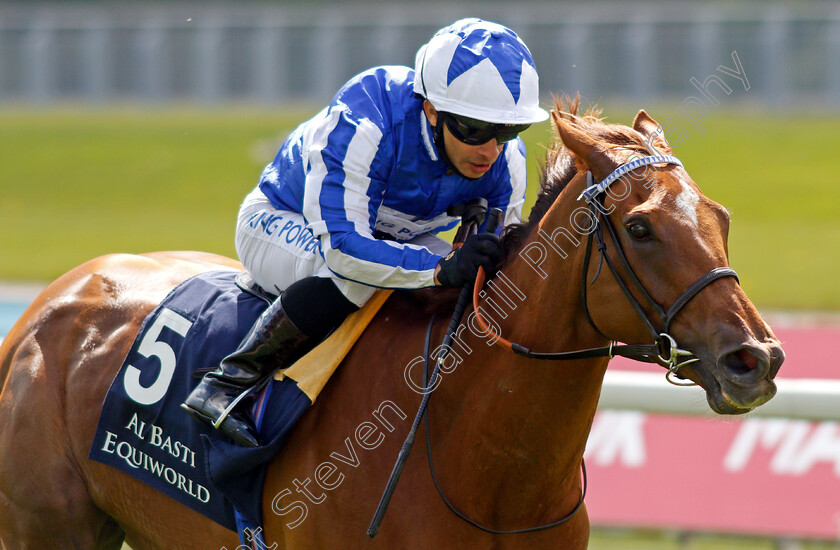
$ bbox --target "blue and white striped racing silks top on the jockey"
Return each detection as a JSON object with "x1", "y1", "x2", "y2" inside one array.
[{"x1": 259, "y1": 66, "x2": 527, "y2": 288}]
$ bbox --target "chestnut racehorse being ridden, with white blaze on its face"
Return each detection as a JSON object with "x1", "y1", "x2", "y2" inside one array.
[{"x1": 0, "y1": 101, "x2": 784, "y2": 550}]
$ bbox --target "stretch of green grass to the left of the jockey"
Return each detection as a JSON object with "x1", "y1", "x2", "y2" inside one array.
[{"x1": 0, "y1": 109, "x2": 316, "y2": 280}]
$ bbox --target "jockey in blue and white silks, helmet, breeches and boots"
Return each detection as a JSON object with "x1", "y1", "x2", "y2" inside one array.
[{"x1": 181, "y1": 19, "x2": 548, "y2": 446}]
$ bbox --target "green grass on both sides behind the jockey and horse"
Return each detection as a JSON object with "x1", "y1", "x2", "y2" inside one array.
[{"x1": 0, "y1": 103, "x2": 840, "y2": 310}]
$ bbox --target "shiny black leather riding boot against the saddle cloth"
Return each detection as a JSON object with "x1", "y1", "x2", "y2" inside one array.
[{"x1": 181, "y1": 298, "x2": 317, "y2": 447}]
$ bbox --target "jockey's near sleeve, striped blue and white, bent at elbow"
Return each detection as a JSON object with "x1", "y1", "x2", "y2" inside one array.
[{"x1": 303, "y1": 103, "x2": 441, "y2": 288}]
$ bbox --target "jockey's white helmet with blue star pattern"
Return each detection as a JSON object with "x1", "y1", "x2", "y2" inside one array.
[{"x1": 414, "y1": 18, "x2": 548, "y2": 124}]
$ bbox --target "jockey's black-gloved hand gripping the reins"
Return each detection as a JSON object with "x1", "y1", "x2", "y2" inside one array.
[{"x1": 436, "y1": 233, "x2": 502, "y2": 287}]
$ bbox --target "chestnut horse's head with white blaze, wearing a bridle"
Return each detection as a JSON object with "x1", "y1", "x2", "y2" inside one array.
[{"x1": 535, "y1": 98, "x2": 784, "y2": 414}]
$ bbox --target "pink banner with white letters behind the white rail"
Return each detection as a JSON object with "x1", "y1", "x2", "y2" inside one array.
[{"x1": 585, "y1": 324, "x2": 840, "y2": 540}]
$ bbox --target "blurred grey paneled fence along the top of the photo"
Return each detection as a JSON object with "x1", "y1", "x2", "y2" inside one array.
[{"x1": 0, "y1": 1, "x2": 840, "y2": 109}]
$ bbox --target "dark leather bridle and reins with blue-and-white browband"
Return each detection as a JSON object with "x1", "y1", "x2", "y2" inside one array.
[{"x1": 473, "y1": 154, "x2": 738, "y2": 386}]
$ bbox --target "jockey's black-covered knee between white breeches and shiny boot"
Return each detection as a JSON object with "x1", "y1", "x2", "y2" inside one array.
[{"x1": 280, "y1": 277, "x2": 359, "y2": 339}]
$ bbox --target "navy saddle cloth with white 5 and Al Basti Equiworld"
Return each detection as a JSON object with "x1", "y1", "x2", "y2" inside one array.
[{"x1": 90, "y1": 271, "x2": 311, "y2": 531}]
